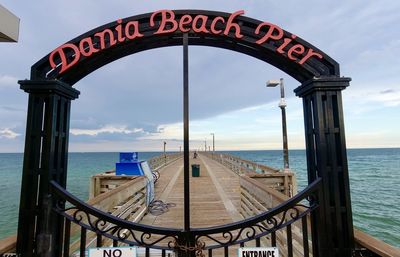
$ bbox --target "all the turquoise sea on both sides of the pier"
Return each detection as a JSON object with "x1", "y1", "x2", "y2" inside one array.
[{"x1": 0, "y1": 148, "x2": 400, "y2": 247}]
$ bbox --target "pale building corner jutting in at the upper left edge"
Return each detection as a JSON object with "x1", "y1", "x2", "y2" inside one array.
[{"x1": 0, "y1": 4, "x2": 19, "y2": 42}]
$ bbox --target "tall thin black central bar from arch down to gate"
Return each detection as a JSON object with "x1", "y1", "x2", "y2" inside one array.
[{"x1": 183, "y1": 33, "x2": 190, "y2": 231}]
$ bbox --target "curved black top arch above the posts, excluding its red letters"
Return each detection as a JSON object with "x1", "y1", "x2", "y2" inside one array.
[{"x1": 31, "y1": 10, "x2": 340, "y2": 85}]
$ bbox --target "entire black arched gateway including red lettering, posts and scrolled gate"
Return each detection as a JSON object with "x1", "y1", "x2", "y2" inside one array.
[{"x1": 17, "y1": 10, "x2": 354, "y2": 257}]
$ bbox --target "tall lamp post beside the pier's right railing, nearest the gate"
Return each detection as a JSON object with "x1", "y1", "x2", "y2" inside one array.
[{"x1": 267, "y1": 78, "x2": 289, "y2": 171}]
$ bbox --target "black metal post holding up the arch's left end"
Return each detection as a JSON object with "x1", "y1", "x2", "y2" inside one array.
[{"x1": 17, "y1": 80, "x2": 79, "y2": 257}]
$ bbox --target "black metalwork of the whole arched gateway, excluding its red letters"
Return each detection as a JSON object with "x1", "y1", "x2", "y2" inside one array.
[{"x1": 17, "y1": 10, "x2": 354, "y2": 257}]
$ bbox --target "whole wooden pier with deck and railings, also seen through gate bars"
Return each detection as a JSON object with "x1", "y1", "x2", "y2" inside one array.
[{"x1": 0, "y1": 153, "x2": 400, "y2": 257}]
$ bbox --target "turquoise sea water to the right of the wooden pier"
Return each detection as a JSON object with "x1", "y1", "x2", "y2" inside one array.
[{"x1": 227, "y1": 148, "x2": 400, "y2": 247}]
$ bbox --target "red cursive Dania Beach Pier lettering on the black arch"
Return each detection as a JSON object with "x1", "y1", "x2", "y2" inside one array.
[{"x1": 49, "y1": 10, "x2": 323, "y2": 74}]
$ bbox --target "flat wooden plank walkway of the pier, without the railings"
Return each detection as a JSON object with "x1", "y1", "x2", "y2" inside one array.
[{"x1": 141, "y1": 155, "x2": 243, "y2": 228}]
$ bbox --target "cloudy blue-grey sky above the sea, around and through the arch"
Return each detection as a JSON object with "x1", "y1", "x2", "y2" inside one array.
[{"x1": 0, "y1": 0, "x2": 400, "y2": 152}]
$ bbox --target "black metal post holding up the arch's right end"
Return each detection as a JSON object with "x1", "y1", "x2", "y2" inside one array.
[{"x1": 295, "y1": 77, "x2": 354, "y2": 257}]
